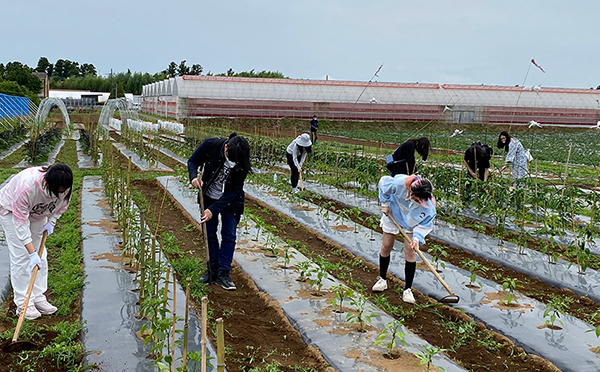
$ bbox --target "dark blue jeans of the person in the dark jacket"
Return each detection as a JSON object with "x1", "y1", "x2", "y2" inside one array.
[{"x1": 204, "y1": 197, "x2": 241, "y2": 272}]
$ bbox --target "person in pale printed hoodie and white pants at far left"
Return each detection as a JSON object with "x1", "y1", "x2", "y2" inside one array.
[{"x1": 0, "y1": 164, "x2": 73, "y2": 319}]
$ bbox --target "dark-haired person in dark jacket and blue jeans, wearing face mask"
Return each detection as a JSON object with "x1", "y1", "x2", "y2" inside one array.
[{"x1": 187, "y1": 132, "x2": 252, "y2": 290}]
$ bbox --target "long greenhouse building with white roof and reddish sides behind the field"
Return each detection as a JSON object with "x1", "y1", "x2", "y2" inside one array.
[{"x1": 142, "y1": 75, "x2": 600, "y2": 126}]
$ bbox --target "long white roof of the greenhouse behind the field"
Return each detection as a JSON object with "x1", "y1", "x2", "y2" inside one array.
[{"x1": 143, "y1": 75, "x2": 600, "y2": 109}]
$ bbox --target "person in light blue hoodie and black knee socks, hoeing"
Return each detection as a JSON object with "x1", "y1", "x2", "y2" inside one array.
[{"x1": 373, "y1": 174, "x2": 436, "y2": 304}]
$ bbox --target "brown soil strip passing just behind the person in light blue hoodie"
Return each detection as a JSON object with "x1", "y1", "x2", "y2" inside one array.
[{"x1": 304, "y1": 194, "x2": 600, "y2": 326}]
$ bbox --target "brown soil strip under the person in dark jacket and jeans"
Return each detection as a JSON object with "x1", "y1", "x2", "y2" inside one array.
[{"x1": 133, "y1": 180, "x2": 329, "y2": 372}]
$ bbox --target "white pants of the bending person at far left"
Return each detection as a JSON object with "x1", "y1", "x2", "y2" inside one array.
[{"x1": 0, "y1": 213, "x2": 48, "y2": 309}]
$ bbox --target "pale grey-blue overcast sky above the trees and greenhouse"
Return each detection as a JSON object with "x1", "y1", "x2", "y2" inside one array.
[{"x1": 0, "y1": 0, "x2": 600, "y2": 88}]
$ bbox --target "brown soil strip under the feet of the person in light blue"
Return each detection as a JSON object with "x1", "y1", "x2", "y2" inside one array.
[{"x1": 247, "y1": 197, "x2": 557, "y2": 372}]
